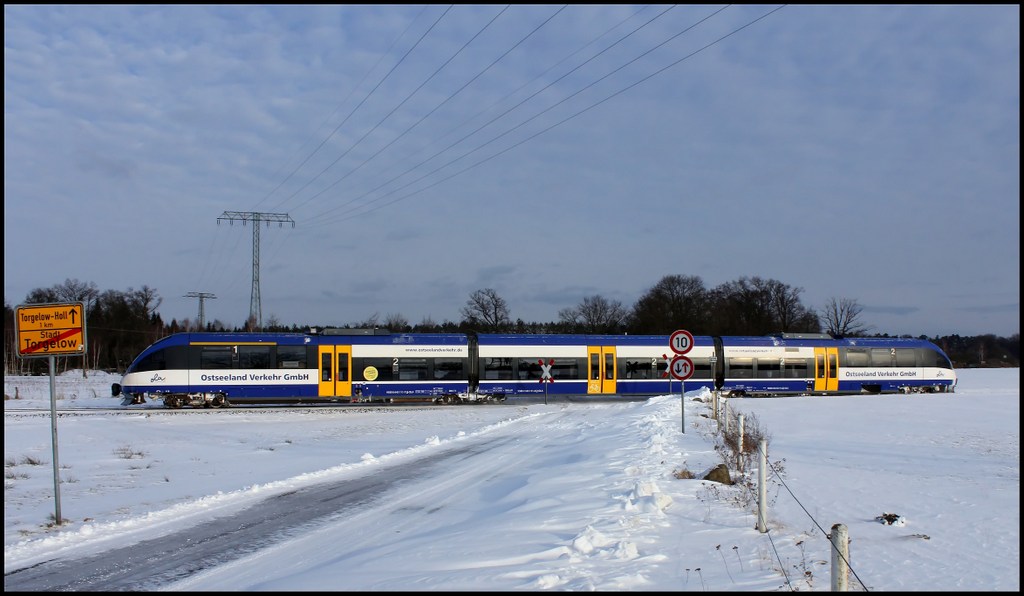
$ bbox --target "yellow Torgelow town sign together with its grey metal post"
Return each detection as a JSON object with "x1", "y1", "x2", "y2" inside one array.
[{"x1": 14, "y1": 302, "x2": 86, "y2": 525}]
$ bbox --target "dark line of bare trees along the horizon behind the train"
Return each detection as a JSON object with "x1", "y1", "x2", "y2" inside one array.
[{"x1": 4, "y1": 274, "x2": 1020, "y2": 374}]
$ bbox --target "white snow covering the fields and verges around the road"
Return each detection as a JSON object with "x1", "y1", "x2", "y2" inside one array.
[{"x1": 4, "y1": 369, "x2": 1020, "y2": 591}]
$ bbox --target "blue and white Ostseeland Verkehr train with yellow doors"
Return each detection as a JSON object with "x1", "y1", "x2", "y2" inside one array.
[{"x1": 112, "y1": 329, "x2": 956, "y2": 409}]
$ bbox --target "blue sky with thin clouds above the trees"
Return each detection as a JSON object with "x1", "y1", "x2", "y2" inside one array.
[{"x1": 4, "y1": 4, "x2": 1020, "y2": 337}]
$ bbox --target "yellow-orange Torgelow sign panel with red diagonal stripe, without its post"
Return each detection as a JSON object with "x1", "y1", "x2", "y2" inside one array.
[{"x1": 14, "y1": 302, "x2": 86, "y2": 358}]
